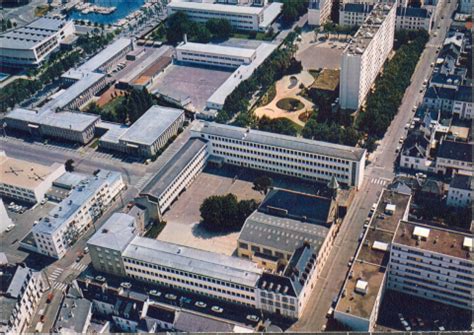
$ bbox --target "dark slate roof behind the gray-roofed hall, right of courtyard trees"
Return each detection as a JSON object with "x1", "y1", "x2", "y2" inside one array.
[{"x1": 258, "y1": 189, "x2": 332, "y2": 223}]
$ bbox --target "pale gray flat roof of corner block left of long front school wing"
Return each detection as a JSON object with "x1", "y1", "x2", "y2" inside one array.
[{"x1": 87, "y1": 213, "x2": 137, "y2": 252}]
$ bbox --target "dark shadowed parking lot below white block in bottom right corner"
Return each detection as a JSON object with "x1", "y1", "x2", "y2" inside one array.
[{"x1": 377, "y1": 290, "x2": 472, "y2": 331}]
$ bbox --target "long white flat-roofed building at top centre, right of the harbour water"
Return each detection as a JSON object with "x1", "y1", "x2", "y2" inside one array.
[{"x1": 166, "y1": 1, "x2": 282, "y2": 31}]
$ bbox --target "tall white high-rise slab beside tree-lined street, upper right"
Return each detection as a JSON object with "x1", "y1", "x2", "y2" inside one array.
[{"x1": 339, "y1": 3, "x2": 396, "y2": 110}]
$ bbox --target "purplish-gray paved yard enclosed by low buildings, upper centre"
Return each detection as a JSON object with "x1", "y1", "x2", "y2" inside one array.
[{"x1": 150, "y1": 64, "x2": 232, "y2": 111}]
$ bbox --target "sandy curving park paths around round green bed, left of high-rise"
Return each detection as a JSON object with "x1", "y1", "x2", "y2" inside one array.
[{"x1": 254, "y1": 71, "x2": 314, "y2": 127}]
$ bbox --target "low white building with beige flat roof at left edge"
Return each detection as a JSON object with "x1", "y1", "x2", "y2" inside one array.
[{"x1": 0, "y1": 151, "x2": 65, "y2": 204}]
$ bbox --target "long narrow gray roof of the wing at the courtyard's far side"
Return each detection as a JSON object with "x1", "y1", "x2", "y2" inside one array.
[{"x1": 194, "y1": 122, "x2": 365, "y2": 161}]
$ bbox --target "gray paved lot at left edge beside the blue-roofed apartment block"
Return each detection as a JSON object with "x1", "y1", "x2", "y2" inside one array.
[{"x1": 0, "y1": 199, "x2": 55, "y2": 262}]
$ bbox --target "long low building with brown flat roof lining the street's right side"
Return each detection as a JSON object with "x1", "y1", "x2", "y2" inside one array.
[{"x1": 334, "y1": 189, "x2": 411, "y2": 332}]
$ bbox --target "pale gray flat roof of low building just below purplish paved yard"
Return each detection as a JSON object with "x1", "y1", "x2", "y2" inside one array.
[{"x1": 120, "y1": 106, "x2": 184, "y2": 145}]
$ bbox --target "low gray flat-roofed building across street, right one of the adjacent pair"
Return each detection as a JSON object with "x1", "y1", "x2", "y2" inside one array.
[{"x1": 99, "y1": 105, "x2": 185, "y2": 158}]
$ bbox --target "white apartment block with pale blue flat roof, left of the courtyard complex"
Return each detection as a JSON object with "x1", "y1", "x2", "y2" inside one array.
[{"x1": 31, "y1": 170, "x2": 125, "y2": 259}]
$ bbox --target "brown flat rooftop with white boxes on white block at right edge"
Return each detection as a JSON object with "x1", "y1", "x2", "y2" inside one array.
[{"x1": 393, "y1": 221, "x2": 472, "y2": 262}]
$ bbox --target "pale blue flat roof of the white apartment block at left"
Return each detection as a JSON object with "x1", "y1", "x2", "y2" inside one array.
[{"x1": 32, "y1": 170, "x2": 121, "y2": 234}]
